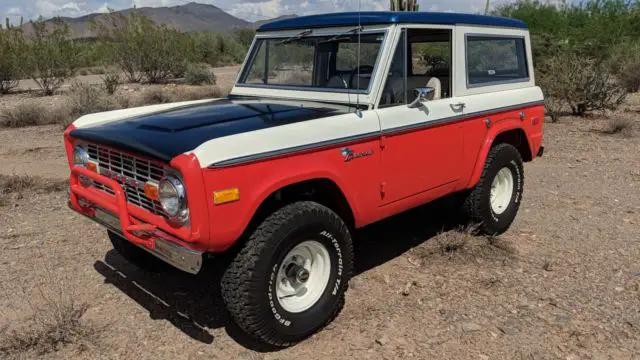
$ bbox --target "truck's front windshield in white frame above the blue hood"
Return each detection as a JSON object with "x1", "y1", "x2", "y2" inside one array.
[{"x1": 239, "y1": 31, "x2": 384, "y2": 92}]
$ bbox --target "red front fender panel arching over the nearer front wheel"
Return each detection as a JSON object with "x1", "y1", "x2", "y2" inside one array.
[{"x1": 203, "y1": 144, "x2": 379, "y2": 252}]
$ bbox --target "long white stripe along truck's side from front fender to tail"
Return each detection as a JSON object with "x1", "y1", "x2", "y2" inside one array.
[{"x1": 193, "y1": 87, "x2": 543, "y2": 167}]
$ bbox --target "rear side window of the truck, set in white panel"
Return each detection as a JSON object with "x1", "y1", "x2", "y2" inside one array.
[{"x1": 466, "y1": 35, "x2": 529, "y2": 87}]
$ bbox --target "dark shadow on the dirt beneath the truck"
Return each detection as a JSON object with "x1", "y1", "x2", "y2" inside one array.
[{"x1": 94, "y1": 194, "x2": 460, "y2": 352}]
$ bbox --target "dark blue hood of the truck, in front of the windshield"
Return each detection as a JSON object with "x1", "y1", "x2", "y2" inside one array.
[{"x1": 70, "y1": 98, "x2": 348, "y2": 162}]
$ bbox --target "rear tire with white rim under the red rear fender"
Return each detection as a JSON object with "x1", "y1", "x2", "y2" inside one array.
[{"x1": 463, "y1": 144, "x2": 524, "y2": 234}]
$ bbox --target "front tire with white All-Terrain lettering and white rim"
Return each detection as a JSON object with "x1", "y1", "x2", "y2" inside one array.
[{"x1": 221, "y1": 202, "x2": 353, "y2": 347}]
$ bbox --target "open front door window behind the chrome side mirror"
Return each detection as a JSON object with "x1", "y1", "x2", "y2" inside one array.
[{"x1": 379, "y1": 29, "x2": 451, "y2": 107}]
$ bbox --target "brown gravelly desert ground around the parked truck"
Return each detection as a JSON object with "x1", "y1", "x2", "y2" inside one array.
[{"x1": 0, "y1": 75, "x2": 640, "y2": 360}]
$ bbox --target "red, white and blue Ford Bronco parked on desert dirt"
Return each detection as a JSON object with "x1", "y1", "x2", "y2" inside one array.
[{"x1": 65, "y1": 12, "x2": 544, "y2": 346}]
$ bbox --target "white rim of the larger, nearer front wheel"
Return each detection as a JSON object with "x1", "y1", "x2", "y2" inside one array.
[{"x1": 276, "y1": 240, "x2": 331, "y2": 313}]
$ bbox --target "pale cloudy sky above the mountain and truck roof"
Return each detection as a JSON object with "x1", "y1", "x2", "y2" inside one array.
[{"x1": 0, "y1": 0, "x2": 503, "y2": 23}]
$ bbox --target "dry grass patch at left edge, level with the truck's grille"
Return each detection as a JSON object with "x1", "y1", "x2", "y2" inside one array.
[{"x1": 0, "y1": 174, "x2": 69, "y2": 206}]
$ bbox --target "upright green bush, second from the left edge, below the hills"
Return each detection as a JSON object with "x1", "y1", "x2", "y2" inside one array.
[{"x1": 25, "y1": 19, "x2": 78, "y2": 95}]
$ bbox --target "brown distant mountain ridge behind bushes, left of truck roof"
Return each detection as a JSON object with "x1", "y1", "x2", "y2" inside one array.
[{"x1": 24, "y1": 2, "x2": 296, "y2": 39}]
